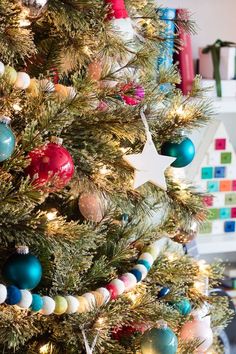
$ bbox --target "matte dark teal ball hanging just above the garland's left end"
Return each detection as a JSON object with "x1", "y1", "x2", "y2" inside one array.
[{"x1": 2, "y1": 246, "x2": 42, "y2": 289}]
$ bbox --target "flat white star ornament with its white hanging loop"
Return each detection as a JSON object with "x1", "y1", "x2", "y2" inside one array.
[{"x1": 123, "y1": 110, "x2": 175, "y2": 190}]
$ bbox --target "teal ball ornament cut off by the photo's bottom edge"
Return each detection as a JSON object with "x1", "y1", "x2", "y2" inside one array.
[{"x1": 141, "y1": 327, "x2": 178, "y2": 354}]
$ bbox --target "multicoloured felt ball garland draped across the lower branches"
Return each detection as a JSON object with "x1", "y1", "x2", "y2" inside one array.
[{"x1": 0, "y1": 241, "x2": 160, "y2": 316}]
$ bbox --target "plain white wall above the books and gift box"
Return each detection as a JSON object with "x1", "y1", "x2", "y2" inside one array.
[{"x1": 157, "y1": 0, "x2": 236, "y2": 58}]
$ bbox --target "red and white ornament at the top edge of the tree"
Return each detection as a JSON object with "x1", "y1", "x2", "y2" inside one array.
[{"x1": 106, "y1": 0, "x2": 135, "y2": 42}]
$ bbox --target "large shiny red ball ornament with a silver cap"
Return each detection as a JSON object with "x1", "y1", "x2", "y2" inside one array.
[{"x1": 26, "y1": 137, "x2": 74, "y2": 192}]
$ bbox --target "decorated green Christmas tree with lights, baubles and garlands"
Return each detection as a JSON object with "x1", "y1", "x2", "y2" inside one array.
[{"x1": 0, "y1": 0, "x2": 230, "y2": 354}]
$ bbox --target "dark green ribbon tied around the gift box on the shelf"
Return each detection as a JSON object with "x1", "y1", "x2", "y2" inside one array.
[{"x1": 202, "y1": 39, "x2": 236, "y2": 97}]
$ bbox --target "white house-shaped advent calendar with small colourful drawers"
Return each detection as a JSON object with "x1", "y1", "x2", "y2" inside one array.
[{"x1": 187, "y1": 121, "x2": 236, "y2": 235}]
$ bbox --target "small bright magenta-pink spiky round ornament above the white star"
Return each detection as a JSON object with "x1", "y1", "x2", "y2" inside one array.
[{"x1": 120, "y1": 82, "x2": 145, "y2": 106}]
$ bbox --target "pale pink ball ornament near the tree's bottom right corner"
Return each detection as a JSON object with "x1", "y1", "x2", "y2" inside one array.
[{"x1": 180, "y1": 319, "x2": 213, "y2": 354}]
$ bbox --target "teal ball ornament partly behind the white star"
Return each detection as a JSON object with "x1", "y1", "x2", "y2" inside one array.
[{"x1": 161, "y1": 138, "x2": 195, "y2": 168}]
